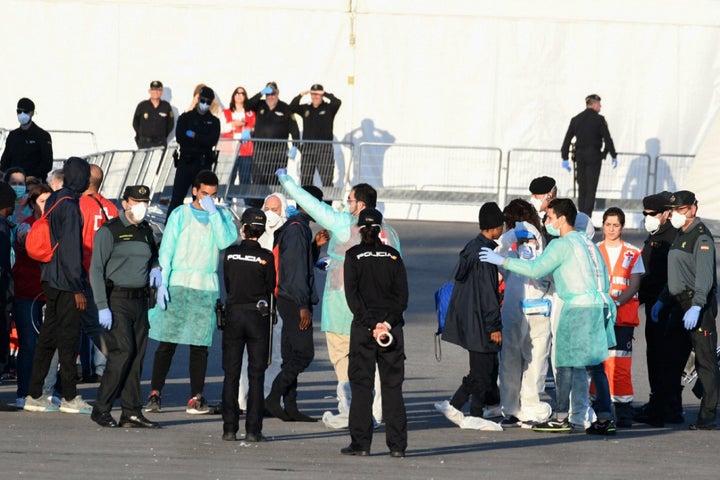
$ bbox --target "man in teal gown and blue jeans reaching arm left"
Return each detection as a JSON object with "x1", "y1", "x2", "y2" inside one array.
[{"x1": 479, "y1": 199, "x2": 616, "y2": 435}]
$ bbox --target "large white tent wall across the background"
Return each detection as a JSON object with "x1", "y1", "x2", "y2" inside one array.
[{"x1": 0, "y1": 0, "x2": 720, "y2": 218}]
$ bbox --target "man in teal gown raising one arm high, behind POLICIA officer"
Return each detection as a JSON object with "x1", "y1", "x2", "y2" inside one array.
[{"x1": 276, "y1": 168, "x2": 402, "y2": 428}]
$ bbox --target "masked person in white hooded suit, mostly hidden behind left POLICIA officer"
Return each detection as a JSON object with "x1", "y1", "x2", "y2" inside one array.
[{"x1": 238, "y1": 193, "x2": 287, "y2": 410}]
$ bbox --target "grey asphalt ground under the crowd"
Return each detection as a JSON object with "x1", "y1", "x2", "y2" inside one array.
[{"x1": 0, "y1": 221, "x2": 720, "y2": 480}]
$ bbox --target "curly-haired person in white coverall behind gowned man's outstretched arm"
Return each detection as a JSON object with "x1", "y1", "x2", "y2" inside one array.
[{"x1": 496, "y1": 203, "x2": 554, "y2": 428}]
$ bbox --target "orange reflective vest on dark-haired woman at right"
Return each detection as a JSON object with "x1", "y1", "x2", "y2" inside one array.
[{"x1": 598, "y1": 242, "x2": 641, "y2": 327}]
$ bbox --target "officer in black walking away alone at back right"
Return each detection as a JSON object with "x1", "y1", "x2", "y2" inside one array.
[{"x1": 560, "y1": 94, "x2": 617, "y2": 216}]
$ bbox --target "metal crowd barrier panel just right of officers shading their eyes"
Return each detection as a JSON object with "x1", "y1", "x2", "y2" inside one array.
[{"x1": 351, "y1": 142, "x2": 502, "y2": 204}]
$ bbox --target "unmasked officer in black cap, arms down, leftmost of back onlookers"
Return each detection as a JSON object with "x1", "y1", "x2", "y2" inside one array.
[{"x1": 133, "y1": 80, "x2": 175, "y2": 148}]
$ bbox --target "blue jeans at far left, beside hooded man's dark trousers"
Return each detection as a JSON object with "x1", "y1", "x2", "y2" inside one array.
[{"x1": 13, "y1": 298, "x2": 45, "y2": 398}]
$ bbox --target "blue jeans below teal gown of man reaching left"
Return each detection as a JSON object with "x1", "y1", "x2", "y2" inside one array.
[{"x1": 555, "y1": 363, "x2": 613, "y2": 420}]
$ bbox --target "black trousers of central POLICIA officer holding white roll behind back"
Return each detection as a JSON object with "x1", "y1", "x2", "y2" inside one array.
[{"x1": 348, "y1": 322, "x2": 407, "y2": 452}]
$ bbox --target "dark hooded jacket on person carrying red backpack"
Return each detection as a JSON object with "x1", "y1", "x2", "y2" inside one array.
[{"x1": 40, "y1": 157, "x2": 90, "y2": 293}]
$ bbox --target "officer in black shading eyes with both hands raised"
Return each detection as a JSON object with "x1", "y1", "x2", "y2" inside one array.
[{"x1": 290, "y1": 83, "x2": 342, "y2": 187}]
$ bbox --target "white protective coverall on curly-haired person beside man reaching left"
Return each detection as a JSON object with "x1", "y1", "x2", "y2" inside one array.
[{"x1": 496, "y1": 222, "x2": 555, "y2": 422}]
